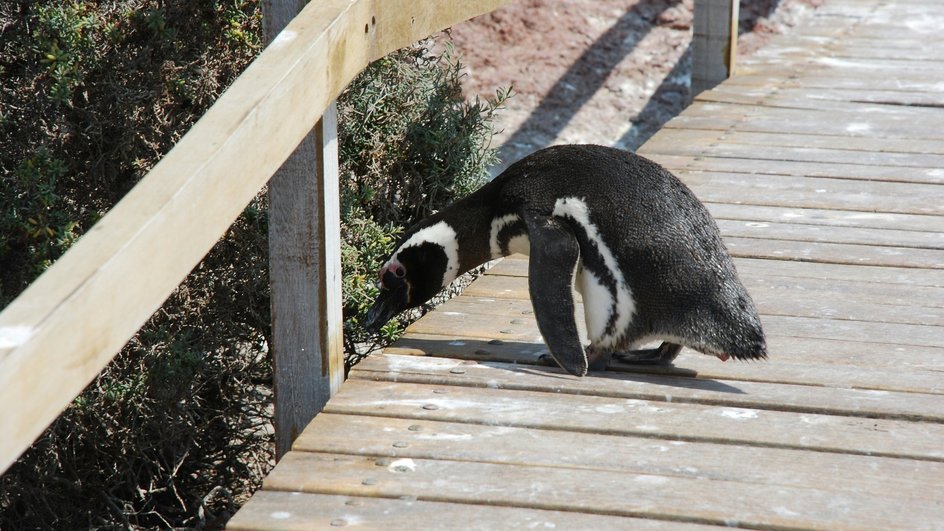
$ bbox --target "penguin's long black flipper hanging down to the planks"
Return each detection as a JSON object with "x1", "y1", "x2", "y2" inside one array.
[{"x1": 522, "y1": 215, "x2": 587, "y2": 376}]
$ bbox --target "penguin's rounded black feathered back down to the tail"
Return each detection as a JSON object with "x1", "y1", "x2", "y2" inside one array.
[{"x1": 488, "y1": 145, "x2": 766, "y2": 358}]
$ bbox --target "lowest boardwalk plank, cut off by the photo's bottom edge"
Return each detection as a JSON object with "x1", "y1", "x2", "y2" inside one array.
[{"x1": 226, "y1": 490, "x2": 700, "y2": 531}]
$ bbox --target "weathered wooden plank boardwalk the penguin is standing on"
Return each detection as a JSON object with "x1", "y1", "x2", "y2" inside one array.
[{"x1": 229, "y1": 0, "x2": 944, "y2": 529}]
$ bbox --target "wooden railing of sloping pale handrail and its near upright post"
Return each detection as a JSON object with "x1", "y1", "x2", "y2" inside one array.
[{"x1": 0, "y1": 0, "x2": 736, "y2": 472}]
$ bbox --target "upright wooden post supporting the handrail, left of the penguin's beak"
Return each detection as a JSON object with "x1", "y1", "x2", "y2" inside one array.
[{"x1": 263, "y1": 0, "x2": 344, "y2": 458}]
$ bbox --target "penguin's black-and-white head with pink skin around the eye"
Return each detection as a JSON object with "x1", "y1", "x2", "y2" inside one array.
[{"x1": 366, "y1": 221, "x2": 459, "y2": 333}]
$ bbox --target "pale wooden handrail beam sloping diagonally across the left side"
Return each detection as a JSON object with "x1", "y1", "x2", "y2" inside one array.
[{"x1": 0, "y1": 0, "x2": 505, "y2": 476}]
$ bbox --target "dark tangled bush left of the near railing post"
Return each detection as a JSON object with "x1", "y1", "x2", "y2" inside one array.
[{"x1": 0, "y1": 0, "x2": 272, "y2": 529}]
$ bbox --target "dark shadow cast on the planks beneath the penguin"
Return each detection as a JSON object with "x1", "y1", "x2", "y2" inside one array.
[{"x1": 392, "y1": 337, "x2": 747, "y2": 394}]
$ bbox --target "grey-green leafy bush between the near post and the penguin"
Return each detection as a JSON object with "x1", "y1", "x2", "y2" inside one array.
[{"x1": 338, "y1": 45, "x2": 508, "y2": 363}]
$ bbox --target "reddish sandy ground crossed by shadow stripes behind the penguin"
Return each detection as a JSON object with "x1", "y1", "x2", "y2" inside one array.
[{"x1": 438, "y1": 0, "x2": 828, "y2": 173}]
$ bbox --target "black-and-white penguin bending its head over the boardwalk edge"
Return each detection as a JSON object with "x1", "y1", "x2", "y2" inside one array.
[{"x1": 367, "y1": 145, "x2": 767, "y2": 376}]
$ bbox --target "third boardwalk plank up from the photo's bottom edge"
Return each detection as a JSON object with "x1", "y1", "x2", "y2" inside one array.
[{"x1": 293, "y1": 412, "x2": 944, "y2": 501}]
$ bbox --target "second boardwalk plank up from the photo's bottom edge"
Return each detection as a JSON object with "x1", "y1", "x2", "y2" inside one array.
[{"x1": 264, "y1": 452, "x2": 944, "y2": 528}]
